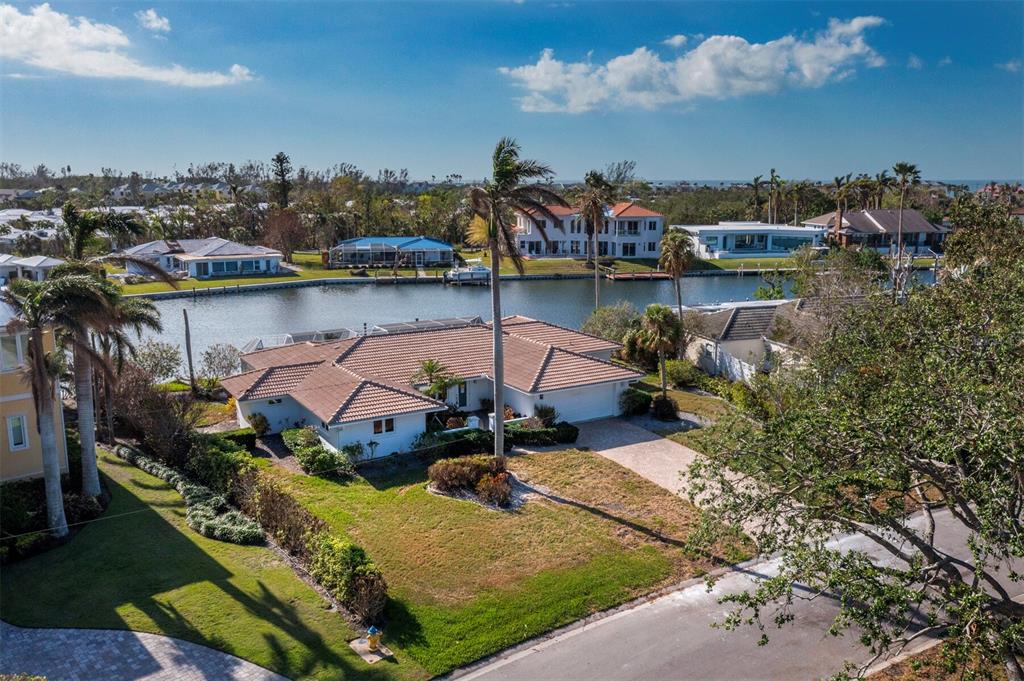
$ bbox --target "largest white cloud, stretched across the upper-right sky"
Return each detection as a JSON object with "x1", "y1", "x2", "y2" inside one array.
[{"x1": 499, "y1": 16, "x2": 885, "y2": 114}]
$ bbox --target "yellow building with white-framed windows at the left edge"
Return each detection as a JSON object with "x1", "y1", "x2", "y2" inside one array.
[{"x1": 0, "y1": 306, "x2": 68, "y2": 481}]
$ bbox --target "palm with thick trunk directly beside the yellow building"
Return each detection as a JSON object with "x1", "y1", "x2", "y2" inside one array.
[{"x1": 0, "y1": 275, "x2": 110, "y2": 537}]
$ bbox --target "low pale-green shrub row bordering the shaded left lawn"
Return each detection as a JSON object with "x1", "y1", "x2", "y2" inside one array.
[{"x1": 115, "y1": 444, "x2": 263, "y2": 544}]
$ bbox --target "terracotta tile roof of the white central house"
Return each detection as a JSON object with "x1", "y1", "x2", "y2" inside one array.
[{"x1": 222, "y1": 316, "x2": 640, "y2": 423}]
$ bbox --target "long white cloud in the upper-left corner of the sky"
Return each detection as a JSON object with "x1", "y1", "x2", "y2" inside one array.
[{"x1": 0, "y1": 4, "x2": 253, "y2": 87}]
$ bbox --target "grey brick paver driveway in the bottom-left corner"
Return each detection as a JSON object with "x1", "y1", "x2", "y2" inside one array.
[{"x1": 0, "y1": 622, "x2": 287, "y2": 681}]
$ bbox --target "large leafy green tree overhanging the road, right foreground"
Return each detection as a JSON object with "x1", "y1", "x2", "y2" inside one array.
[{"x1": 689, "y1": 205, "x2": 1024, "y2": 681}]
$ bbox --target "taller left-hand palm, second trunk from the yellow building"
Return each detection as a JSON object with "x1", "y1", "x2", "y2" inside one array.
[{"x1": 51, "y1": 202, "x2": 177, "y2": 497}]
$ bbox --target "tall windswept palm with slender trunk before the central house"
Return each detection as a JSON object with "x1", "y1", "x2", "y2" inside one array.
[{"x1": 469, "y1": 137, "x2": 567, "y2": 454}]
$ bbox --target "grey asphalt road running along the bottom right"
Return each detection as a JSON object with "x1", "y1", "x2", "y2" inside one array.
[{"x1": 453, "y1": 515, "x2": 1024, "y2": 681}]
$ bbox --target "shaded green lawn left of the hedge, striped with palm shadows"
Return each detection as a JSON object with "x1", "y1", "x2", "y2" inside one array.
[{"x1": 0, "y1": 454, "x2": 427, "y2": 681}]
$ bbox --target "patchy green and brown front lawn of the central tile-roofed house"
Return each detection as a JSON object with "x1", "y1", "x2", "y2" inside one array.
[{"x1": 266, "y1": 450, "x2": 734, "y2": 674}]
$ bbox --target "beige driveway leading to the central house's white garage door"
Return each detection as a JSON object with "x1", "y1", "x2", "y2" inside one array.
[{"x1": 577, "y1": 419, "x2": 702, "y2": 496}]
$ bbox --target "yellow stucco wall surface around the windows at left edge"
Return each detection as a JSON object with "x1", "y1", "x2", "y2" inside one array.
[{"x1": 0, "y1": 328, "x2": 68, "y2": 481}]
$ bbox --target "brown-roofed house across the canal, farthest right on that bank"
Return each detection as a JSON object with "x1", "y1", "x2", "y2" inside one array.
[{"x1": 804, "y1": 208, "x2": 948, "y2": 255}]
